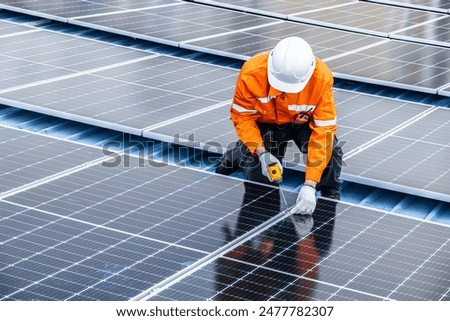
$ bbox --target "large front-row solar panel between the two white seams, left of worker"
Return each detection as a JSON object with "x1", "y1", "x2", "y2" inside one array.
[{"x1": 0, "y1": 146, "x2": 286, "y2": 300}]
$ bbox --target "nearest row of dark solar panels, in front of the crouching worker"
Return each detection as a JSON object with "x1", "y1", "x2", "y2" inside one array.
[{"x1": 0, "y1": 126, "x2": 450, "y2": 301}]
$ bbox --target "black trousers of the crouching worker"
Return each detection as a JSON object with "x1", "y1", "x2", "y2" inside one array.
[{"x1": 240, "y1": 123, "x2": 343, "y2": 196}]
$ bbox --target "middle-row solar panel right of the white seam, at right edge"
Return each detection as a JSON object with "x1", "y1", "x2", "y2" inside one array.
[{"x1": 344, "y1": 108, "x2": 450, "y2": 202}]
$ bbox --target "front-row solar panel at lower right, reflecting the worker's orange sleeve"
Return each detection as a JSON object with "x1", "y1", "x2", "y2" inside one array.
[{"x1": 147, "y1": 199, "x2": 450, "y2": 301}]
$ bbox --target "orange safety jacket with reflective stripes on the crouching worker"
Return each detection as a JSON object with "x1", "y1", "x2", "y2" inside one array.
[{"x1": 230, "y1": 52, "x2": 336, "y2": 182}]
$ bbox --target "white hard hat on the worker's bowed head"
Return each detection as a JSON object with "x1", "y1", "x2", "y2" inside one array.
[{"x1": 267, "y1": 37, "x2": 316, "y2": 93}]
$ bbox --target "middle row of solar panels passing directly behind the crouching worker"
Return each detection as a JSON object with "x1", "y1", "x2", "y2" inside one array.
[{"x1": 0, "y1": 22, "x2": 450, "y2": 201}]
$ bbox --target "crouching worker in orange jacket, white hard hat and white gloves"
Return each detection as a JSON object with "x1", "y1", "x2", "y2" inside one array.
[{"x1": 223, "y1": 36, "x2": 343, "y2": 214}]
